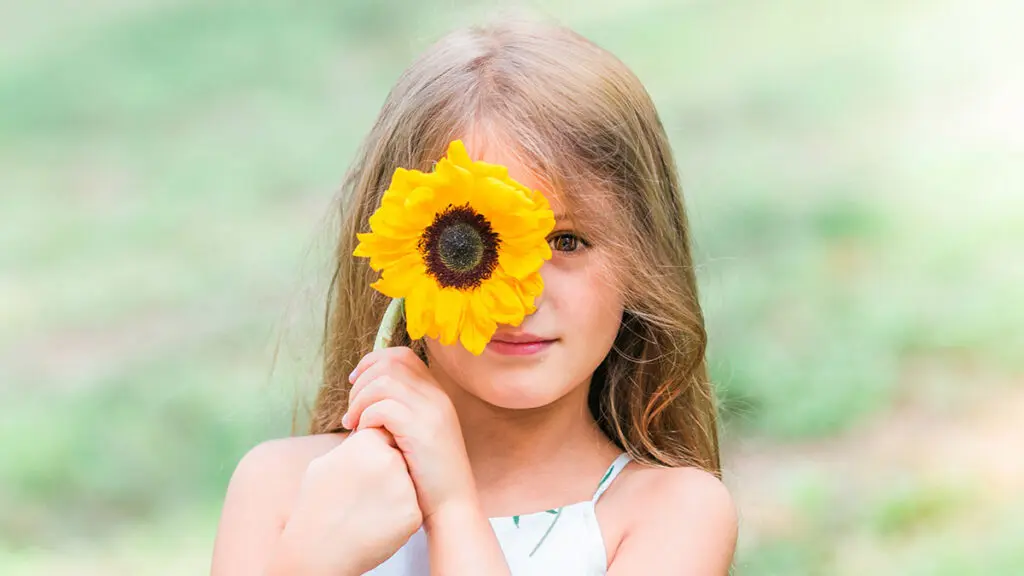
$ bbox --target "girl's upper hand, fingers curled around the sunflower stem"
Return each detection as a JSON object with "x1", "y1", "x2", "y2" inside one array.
[{"x1": 342, "y1": 346, "x2": 476, "y2": 529}]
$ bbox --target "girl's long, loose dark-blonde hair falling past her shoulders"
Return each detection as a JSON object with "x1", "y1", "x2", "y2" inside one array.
[{"x1": 310, "y1": 22, "x2": 721, "y2": 476}]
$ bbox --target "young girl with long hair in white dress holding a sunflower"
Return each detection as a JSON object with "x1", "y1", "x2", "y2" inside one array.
[{"x1": 213, "y1": 19, "x2": 736, "y2": 576}]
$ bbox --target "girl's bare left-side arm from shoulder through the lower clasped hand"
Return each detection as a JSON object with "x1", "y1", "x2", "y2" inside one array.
[{"x1": 211, "y1": 429, "x2": 423, "y2": 576}]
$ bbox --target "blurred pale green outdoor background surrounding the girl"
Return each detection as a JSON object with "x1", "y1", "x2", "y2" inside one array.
[{"x1": 0, "y1": 0, "x2": 1024, "y2": 575}]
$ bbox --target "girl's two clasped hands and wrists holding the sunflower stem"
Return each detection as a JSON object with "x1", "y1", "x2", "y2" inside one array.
[{"x1": 271, "y1": 346, "x2": 508, "y2": 575}]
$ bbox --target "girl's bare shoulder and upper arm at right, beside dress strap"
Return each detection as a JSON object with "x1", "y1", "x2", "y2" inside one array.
[{"x1": 608, "y1": 468, "x2": 738, "y2": 576}]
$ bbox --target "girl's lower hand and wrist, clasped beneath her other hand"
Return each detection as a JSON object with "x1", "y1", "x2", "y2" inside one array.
[{"x1": 268, "y1": 429, "x2": 423, "y2": 576}]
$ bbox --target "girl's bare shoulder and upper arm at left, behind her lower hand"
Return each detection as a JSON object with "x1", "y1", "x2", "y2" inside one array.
[{"x1": 212, "y1": 434, "x2": 347, "y2": 576}]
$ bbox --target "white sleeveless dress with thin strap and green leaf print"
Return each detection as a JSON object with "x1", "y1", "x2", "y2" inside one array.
[{"x1": 364, "y1": 452, "x2": 630, "y2": 576}]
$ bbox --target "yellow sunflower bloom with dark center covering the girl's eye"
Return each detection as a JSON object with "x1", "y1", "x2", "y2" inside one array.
[{"x1": 353, "y1": 140, "x2": 555, "y2": 355}]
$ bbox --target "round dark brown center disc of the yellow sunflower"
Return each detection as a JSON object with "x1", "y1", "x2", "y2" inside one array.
[{"x1": 419, "y1": 204, "x2": 500, "y2": 290}]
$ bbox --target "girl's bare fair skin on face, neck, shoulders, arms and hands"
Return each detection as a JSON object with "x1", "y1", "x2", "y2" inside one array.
[{"x1": 212, "y1": 137, "x2": 736, "y2": 576}]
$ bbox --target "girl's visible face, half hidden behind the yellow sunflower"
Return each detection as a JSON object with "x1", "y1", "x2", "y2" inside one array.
[{"x1": 424, "y1": 138, "x2": 624, "y2": 409}]
